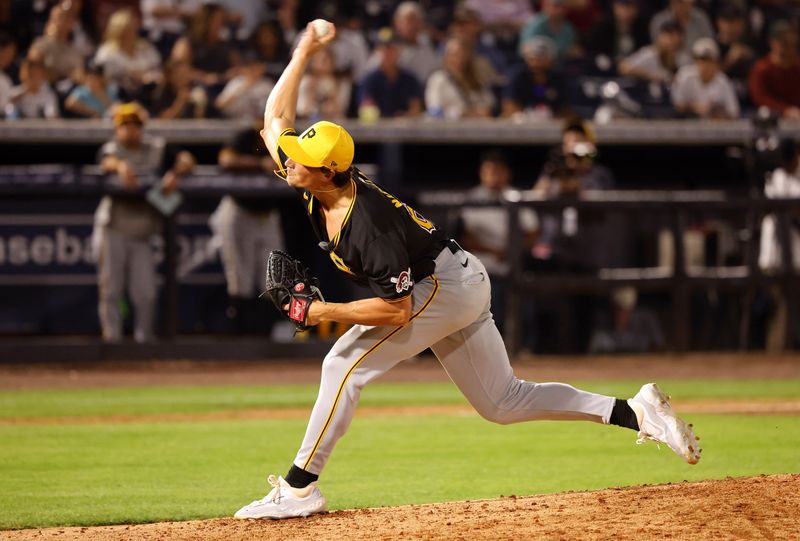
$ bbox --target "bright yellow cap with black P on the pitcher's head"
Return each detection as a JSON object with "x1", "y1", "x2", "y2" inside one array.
[{"x1": 278, "y1": 120, "x2": 355, "y2": 173}]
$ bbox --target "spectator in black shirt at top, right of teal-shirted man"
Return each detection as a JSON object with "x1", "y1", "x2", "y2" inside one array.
[{"x1": 584, "y1": 0, "x2": 650, "y2": 71}]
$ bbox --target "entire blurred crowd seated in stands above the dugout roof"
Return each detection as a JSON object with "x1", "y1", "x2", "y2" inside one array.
[{"x1": 0, "y1": 0, "x2": 800, "y2": 121}]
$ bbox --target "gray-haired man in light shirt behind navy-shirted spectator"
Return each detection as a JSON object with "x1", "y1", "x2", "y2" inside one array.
[{"x1": 392, "y1": 2, "x2": 439, "y2": 85}]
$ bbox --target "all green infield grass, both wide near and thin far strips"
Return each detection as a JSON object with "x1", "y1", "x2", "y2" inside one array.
[{"x1": 0, "y1": 380, "x2": 800, "y2": 529}]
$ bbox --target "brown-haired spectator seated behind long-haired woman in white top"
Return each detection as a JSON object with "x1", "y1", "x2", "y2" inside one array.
[{"x1": 450, "y1": 4, "x2": 508, "y2": 82}]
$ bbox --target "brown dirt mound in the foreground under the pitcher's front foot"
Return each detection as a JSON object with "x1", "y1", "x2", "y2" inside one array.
[{"x1": 7, "y1": 474, "x2": 800, "y2": 541}]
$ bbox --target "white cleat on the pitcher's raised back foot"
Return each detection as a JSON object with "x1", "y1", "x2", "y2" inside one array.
[{"x1": 628, "y1": 383, "x2": 702, "y2": 464}]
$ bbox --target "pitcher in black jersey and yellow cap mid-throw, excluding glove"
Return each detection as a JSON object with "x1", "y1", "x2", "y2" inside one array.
[{"x1": 234, "y1": 23, "x2": 700, "y2": 518}]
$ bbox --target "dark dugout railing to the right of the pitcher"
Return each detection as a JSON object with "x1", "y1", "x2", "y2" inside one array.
[{"x1": 420, "y1": 191, "x2": 800, "y2": 354}]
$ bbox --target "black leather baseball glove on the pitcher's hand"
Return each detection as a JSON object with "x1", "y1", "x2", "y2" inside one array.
[{"x1": 264, "y1": 250, "x2": 325, "y2": 331}]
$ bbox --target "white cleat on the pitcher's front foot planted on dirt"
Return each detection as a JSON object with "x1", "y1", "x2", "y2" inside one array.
[{"x1": 233, "y1": 475, "x2": 325, "y2": 519}]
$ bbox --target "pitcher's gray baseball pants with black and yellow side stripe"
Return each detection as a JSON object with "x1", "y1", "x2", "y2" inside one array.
[{"x1": 294, "y1": 248, "x2": 615, "y2": 474}]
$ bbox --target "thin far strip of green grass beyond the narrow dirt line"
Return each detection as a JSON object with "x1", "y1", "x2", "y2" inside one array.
[{"x1": 0, "y1": 379, "x2": 800, "y2": 418}]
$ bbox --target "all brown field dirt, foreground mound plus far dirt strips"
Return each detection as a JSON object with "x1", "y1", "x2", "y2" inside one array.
[{"x1": 0, "y1": 355, "x2": 800, "y2": 541}]
